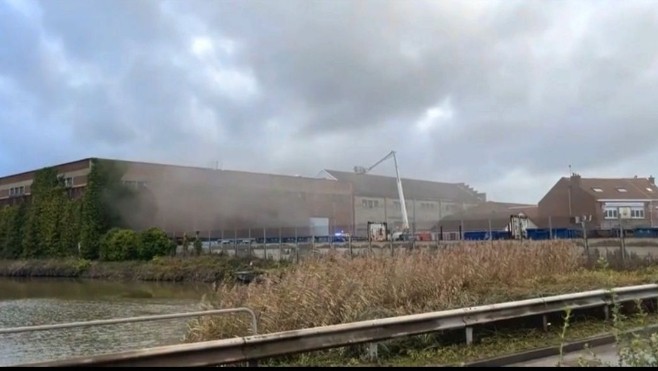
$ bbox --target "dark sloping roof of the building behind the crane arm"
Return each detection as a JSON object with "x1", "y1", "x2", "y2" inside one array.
[{"x1": 324, "y1": 169, "x2": 482, "y2": 203}]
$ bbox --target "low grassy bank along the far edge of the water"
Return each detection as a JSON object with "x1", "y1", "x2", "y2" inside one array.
[{"x1": 0, "y1": 255, "x2": 282, "y2": 282}]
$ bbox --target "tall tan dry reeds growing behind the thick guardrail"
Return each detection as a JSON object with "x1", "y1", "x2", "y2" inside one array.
[{"x1": 187, "y1": 241, "x2": 584, "y2": 341}]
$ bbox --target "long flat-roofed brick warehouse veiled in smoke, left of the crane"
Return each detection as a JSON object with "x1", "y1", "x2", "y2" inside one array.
[{"x1": 0, "y1": 159, "x2": 353, "y2": 238}]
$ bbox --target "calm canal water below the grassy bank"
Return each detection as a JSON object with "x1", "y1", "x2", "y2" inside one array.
[{"x1": 0, "y1": 278, "x2": 209, "y2": 366}]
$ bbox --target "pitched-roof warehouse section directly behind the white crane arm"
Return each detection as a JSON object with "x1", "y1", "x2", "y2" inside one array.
[{"x1": 318, "y1": 169, "x2": 486, "y2": 236}]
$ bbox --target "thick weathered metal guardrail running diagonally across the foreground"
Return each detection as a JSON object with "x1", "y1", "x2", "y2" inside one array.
[{"x1": 22, "y1": 284, "x2": 658, "y2": 367}]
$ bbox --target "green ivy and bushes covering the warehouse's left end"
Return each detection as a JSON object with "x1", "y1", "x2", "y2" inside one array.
[{"x1": 0, "y1": 159, "x2": 176, "y2": 261}]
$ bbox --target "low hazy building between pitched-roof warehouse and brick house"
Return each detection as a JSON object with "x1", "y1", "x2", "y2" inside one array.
[{"x1": 434, "y1": 201, "x2": 537, "y2": 234}]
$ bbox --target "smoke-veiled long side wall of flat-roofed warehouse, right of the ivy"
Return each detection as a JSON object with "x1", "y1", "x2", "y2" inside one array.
[{"x1": 123, "y1": 163, "x2": 353, "y2": 237}]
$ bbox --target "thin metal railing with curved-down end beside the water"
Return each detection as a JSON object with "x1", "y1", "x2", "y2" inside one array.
[{"x1": 0, "y1": 308, "x2": 258, "y2": 335}]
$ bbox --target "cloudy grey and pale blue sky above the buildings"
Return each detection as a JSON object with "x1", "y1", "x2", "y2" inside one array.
[{"x1": 0, "y1": 0, "x2": 658, "y2": 203}]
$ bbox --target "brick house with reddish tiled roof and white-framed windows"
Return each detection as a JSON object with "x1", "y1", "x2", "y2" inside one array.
[{"x1": 537, "y1": 174, "x2": 658, "y2": 231}]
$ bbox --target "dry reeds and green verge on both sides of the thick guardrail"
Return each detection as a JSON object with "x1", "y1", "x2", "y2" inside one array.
[{"x1": 186, "y1": 241, "x2": 658, "y2": 365}]
